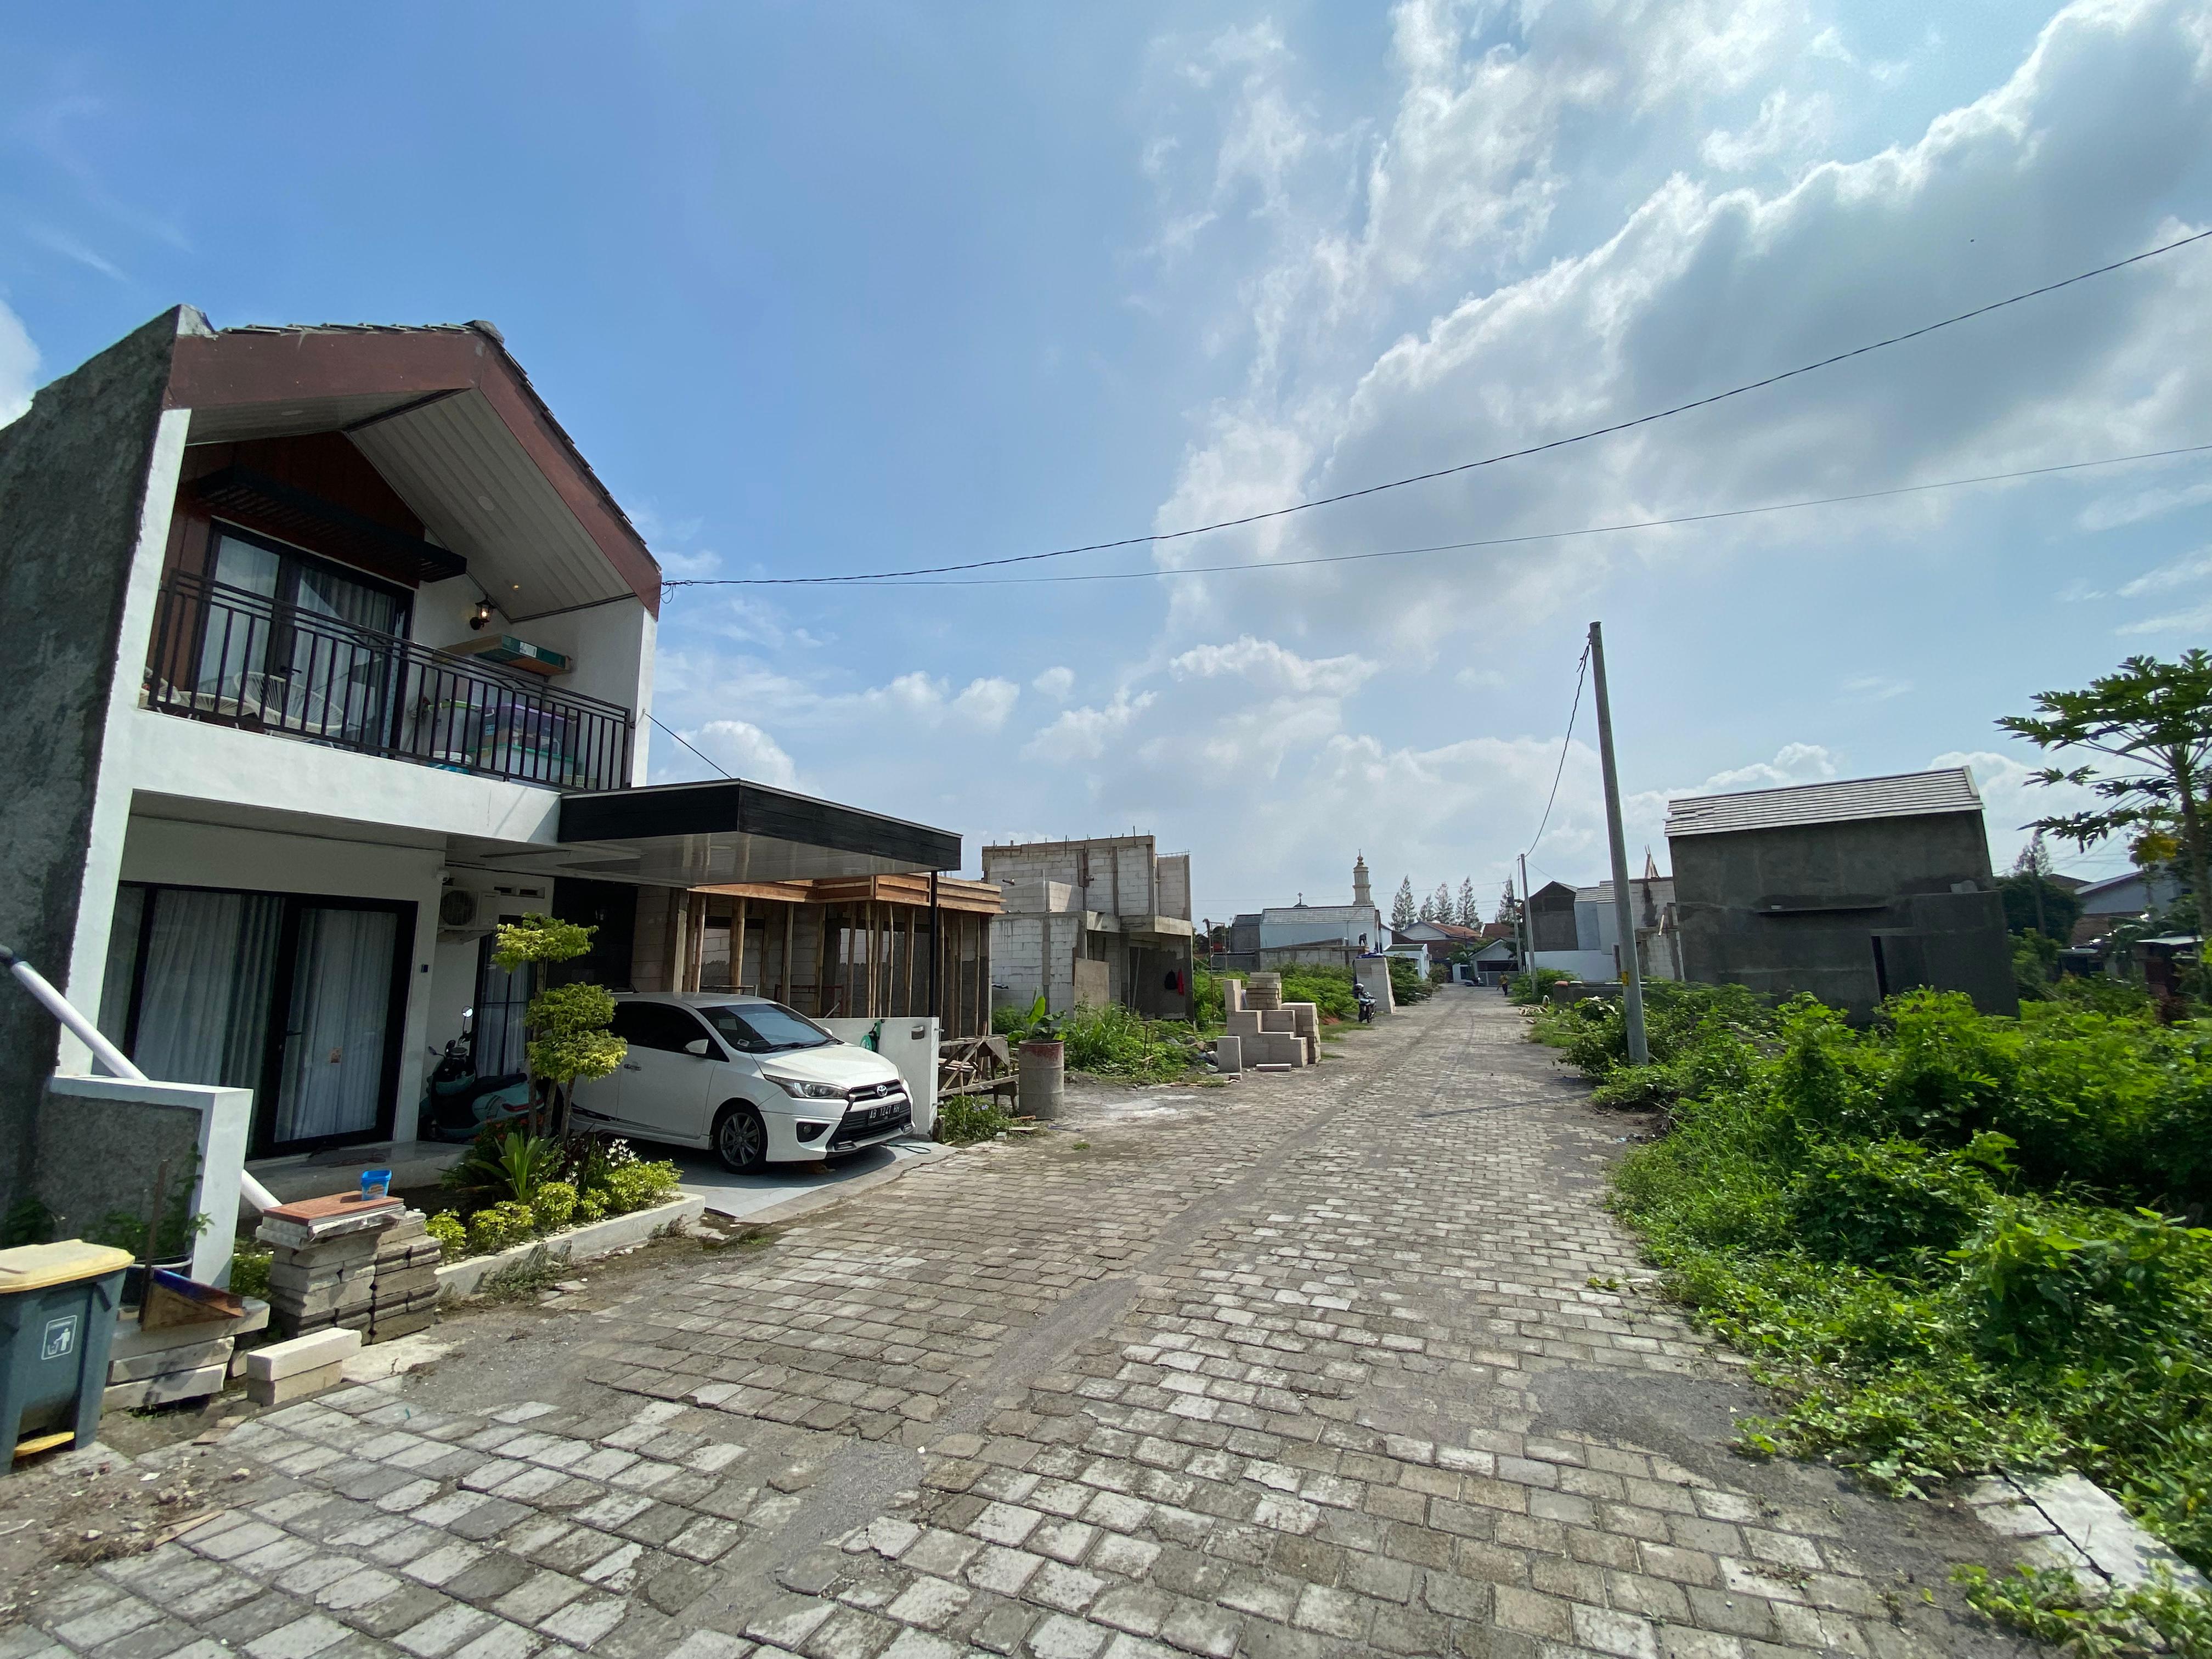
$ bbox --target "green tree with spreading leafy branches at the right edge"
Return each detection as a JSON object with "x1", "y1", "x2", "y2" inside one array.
[{"x1": 1997, "y1": 650, "x2": 2212, "y2": 955}]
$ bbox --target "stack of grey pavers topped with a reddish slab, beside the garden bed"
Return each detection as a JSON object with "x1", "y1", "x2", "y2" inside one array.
[{"x1": 257, "y1": 1194, "x2": 440, "y2": 1342}]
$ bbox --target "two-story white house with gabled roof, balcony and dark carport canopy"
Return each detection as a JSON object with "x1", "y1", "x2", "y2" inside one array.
[{"x1": 0, "y1": 307, "x2": 960, "y2": 1201}]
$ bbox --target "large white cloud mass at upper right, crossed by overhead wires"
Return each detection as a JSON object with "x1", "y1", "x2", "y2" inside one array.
[{"x1": 1157, "y1": 0, "x2": 2212, "y2": 657}]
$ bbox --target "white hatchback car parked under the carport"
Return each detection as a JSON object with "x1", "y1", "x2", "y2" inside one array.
[{"x1": 575, "y1": 991, "x2": 913, "y2": 1175}]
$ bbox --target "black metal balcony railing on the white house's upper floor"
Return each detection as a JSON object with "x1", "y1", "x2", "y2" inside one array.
[{"x1": 146, "y1": 573, "x2": 630, "y2": 789}]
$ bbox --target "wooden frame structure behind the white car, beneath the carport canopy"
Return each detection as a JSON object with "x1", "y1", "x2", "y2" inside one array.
[{"x1": 670, "y1": 876, "x2": 1002, "y2": 1040}]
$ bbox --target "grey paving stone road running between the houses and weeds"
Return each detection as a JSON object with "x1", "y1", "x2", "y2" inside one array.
[{"x1": 0, "y1": 993, "x2": 2019, "y2": 1659}]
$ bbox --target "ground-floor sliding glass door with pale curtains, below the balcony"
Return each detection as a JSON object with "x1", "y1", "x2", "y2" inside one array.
[{"x1": 99, "y1": 883, "x2": 414, "y2": 1157}]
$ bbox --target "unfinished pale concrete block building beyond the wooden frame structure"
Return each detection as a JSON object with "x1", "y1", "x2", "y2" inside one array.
[{"x1": 982, "y1": 836, "x2": 1194, "y2": 1020}]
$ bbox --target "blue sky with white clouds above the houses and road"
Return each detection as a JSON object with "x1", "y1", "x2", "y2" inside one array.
[{"x1": 0, "y1": 0, "x2": 2212, "y2": 918}]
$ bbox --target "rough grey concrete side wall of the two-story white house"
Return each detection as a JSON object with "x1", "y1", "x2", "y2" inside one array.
[{"x1": 0, "y1": 312, "x2": 179, "y2": 1210}]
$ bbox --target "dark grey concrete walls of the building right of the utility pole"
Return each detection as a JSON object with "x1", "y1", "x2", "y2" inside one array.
[{"x1": 1668, "y1": 812, "x2": 2019, "y2": 1022}]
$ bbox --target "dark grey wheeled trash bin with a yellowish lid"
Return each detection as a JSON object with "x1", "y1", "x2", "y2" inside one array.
[{"x1": 0, "y1": 1239, "x2": 131, "y2": 1466}]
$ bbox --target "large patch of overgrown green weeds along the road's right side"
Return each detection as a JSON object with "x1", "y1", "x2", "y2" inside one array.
[{"x1": 1583, "y1": 986, "x2": 2212, "y2": 1601}]
